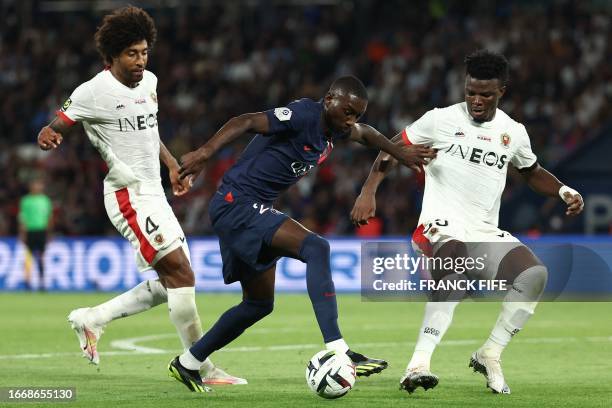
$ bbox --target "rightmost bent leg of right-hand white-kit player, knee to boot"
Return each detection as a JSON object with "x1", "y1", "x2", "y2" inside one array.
[{"x1": 470, "y1": 245, "x2": 548, "y2": 394}]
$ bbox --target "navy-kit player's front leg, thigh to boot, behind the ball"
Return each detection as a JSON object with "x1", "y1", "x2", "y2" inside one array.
[{"x1": 270, "y1": 218, "x2": 388, "y2": 376}]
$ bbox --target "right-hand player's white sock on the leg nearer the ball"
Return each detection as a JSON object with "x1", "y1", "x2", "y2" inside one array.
[{"x1": 406, "y1": 302, "x2": 459, "y2": 371}]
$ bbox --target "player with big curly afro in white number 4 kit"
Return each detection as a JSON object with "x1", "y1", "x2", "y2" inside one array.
[{"x1": 38, "y1": 7, "x2": 246, "y2": 384}]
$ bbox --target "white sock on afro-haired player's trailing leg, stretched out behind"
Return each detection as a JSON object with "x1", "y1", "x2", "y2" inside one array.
[{"x1": 90, "y1": 279, "x2": 167, "y2": 326}]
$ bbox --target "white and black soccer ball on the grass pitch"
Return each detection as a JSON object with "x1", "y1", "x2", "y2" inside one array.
[{"x1": 306, "y1": 350, "x2": 355, "y2": 399}]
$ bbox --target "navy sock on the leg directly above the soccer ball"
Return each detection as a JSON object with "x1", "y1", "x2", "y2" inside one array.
[{"x1": 299, "y1": 234, "x2": 342, "y2": 343}]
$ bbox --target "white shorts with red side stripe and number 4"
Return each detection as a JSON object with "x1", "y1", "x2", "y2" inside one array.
[{"x1": 104, "y1": 185, "x2": 191, "y2": 272}]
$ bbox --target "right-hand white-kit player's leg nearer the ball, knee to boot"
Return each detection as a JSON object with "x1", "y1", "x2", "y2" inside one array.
[{"x1": 400, "y1": 240, "x2": 467, "y2": 393}]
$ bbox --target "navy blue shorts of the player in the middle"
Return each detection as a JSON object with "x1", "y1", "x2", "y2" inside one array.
[{"x1": 208, "y1": 191, "x2": 289, "y2": 284}]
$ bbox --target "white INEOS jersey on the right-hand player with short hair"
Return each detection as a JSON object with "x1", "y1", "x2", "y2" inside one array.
[{"x1": 403, "y1": 102, "x2": 537, "y2": 228}]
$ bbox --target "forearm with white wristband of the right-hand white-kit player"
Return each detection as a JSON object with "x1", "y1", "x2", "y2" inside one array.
[{"x1": 519, "y1": 163, "x2": 584, "y2": 216}]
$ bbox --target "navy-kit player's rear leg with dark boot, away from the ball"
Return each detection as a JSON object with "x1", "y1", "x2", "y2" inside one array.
[{"x1": 168, "y1": 266, "x2": 276, "y2": 392}]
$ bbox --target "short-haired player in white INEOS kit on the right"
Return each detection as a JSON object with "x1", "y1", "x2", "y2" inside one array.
[{"x1": 351, "y1": 50, "x2": 584, "y2": 394}]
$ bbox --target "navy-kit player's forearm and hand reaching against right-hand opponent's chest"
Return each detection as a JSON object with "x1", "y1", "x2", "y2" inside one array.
[{"x1": 351, "y1": 123, "x2": 436, "y2": 171}]
